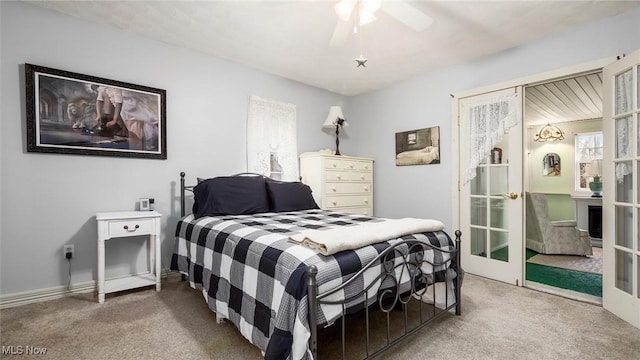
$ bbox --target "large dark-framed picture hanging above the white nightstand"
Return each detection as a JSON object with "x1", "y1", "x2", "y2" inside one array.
[{"x1": 25, "y1": 64, "x2": 167, "y2": 159}]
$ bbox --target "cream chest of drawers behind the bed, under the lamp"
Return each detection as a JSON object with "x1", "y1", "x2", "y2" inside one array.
[{"x1": 300, "y1": 153, "x2": 373, "y2": 216}]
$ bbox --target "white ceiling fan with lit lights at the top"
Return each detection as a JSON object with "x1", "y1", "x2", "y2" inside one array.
[{"x1": 330, "y1": 0, "x2": 433, "y2": 47}]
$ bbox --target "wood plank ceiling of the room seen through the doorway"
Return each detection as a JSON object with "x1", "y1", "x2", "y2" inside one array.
[{"x1": 524, "y1": 72, "x2": 602, "y2": 126}]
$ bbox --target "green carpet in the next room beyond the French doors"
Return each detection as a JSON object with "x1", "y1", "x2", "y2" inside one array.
[{"x1": 491, "y1": 247, "x2": 602, "y2": 297}]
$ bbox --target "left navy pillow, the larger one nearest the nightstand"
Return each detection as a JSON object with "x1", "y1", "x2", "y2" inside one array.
[{"x1": 193, "y1": 176, "x2": 269, "y2": 218}]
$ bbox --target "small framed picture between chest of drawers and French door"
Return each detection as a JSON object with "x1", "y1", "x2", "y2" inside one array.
[{"x1": 396, "y1": 126, "x2": 440, "y2": 166}]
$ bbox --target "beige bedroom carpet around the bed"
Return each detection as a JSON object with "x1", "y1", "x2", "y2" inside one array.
[{"x1": 0, "y1": 275, "x2": 640, "y2": 360}]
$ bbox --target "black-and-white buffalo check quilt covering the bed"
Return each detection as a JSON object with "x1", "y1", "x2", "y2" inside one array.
[{"x1": 171, "y1": 210, "x2": 457, "y2": 359}]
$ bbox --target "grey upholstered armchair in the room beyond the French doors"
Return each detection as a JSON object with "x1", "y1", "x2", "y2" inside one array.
[{"x1": 526, "y1": 193, "x2": 593, "y2": 255}]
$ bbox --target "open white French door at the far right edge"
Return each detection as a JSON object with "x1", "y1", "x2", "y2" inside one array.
[{"x1": 602, "y1": 50, "x2": 640, "y2": 328}]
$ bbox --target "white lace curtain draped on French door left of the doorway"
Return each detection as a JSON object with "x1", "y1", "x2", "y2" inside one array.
[{"x1": 460, "y1": 90, "x2": 520, "y2": 185}]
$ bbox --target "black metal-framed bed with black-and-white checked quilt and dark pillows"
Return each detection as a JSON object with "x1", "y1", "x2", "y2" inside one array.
[{"x1": 171, "y1": 173, "x2": 462, "y2": 359}]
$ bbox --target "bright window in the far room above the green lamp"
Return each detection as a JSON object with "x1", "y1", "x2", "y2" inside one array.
[{"x1": 575, "y1": 131, "x2": 604, "y2": 192}]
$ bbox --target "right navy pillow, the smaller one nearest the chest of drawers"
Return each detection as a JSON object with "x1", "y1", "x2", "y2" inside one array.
[{"x1": 267, "y1": 180, "x2": 318, "y2": 212}]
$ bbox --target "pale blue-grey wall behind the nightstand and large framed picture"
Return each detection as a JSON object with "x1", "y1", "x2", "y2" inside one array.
[{"x1": 0, "y1": 1, "x2": 354, "y2": 295}]
